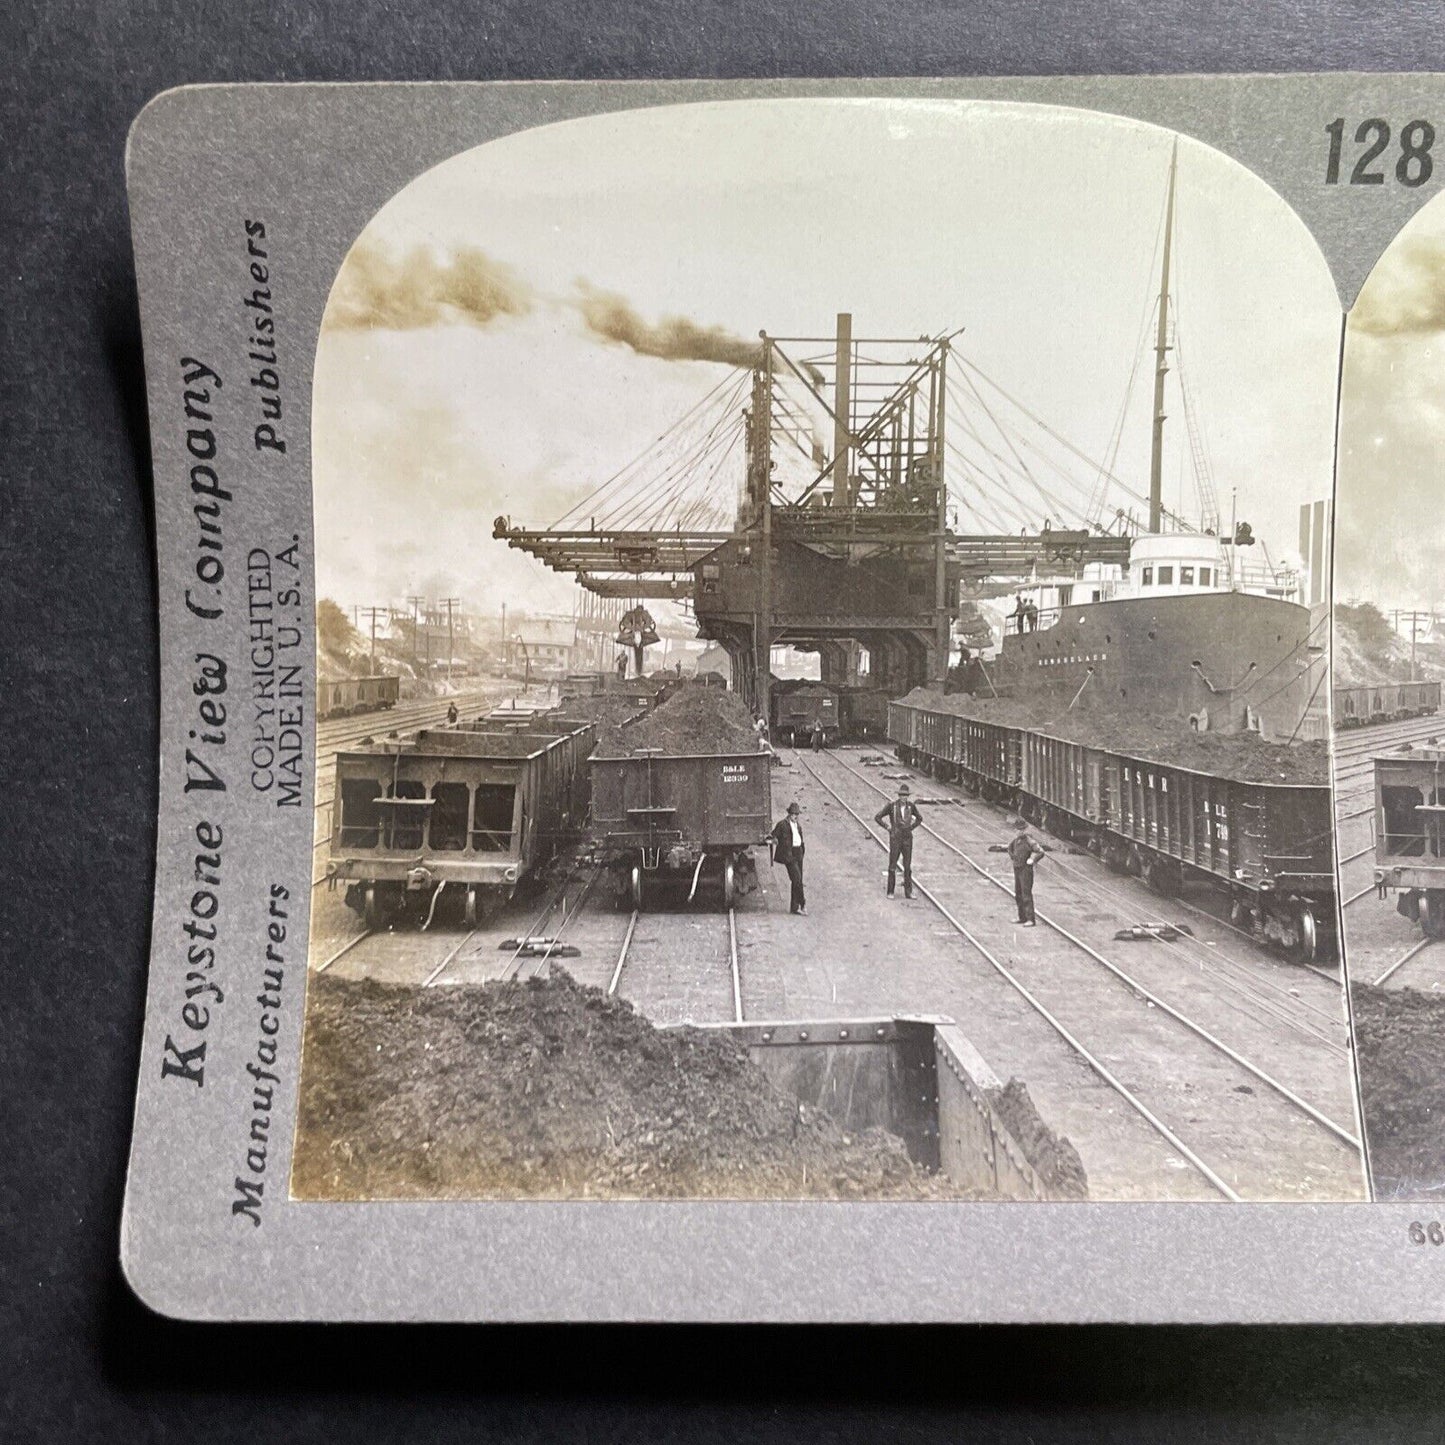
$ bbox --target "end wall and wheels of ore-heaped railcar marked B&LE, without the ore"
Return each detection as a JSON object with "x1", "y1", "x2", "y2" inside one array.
[{"x1": 591, "y1": 750, "x2": 773, "y2": 910}]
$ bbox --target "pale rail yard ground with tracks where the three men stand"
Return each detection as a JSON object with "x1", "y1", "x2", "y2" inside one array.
[{"x1": 296, "y1": 734, "x2": 1364, "y2": 1201}]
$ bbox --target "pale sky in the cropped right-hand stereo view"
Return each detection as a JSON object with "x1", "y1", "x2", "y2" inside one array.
[{"x1": 1335, "y1": 197, "x2": 1445, "y2": 610}]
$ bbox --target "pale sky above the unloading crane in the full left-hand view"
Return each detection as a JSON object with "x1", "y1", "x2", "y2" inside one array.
[{"x1": 314, "y1": 100, "x2": 1340, "y2": 611}]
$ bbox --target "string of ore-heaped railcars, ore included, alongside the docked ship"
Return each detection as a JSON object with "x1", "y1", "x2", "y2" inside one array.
[{"x1": 889, "y1": 689, "x2": 1335, "y2": 961}]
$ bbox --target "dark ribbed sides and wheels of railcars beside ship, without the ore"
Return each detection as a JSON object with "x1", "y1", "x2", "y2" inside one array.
[{"x1": 889, "y1": 702, "x2": 1335, "y2": 961}]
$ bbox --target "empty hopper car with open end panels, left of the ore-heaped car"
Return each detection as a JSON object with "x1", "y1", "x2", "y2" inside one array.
[{"x1": 327, "y1": 723, "x2": 594, "y2": 928}]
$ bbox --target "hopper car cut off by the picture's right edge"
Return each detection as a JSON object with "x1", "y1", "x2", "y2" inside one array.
[{"x1": 1374, "y1": 743, "x2": 1445, "y2": 938}]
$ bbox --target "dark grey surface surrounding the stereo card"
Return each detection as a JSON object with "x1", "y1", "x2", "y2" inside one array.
[{"x1": 8, "y1": 0, "x2": 1445, "y2": 1442}]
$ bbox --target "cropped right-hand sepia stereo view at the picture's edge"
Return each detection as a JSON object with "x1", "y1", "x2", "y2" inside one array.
[{"x1": 1334, "y1": 201, "x2": 1445, "y2": 1199}]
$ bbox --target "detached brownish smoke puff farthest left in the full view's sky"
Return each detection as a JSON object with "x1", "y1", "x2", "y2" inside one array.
[{"x1": 327, "y1": 243, "x2": 536, "y2": 331}]
